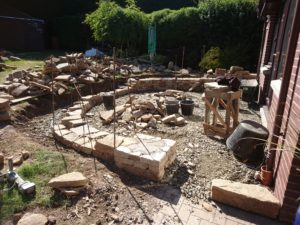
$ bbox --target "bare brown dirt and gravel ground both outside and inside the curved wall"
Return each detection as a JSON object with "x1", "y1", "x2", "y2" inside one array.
[{"x1": 0, "y1": 90, "x2": 260, "y2": 224}]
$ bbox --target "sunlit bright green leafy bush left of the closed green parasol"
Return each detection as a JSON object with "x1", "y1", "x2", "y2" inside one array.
[{"x1": 85, "y1": 1, "x2": 148, "y2": 53}]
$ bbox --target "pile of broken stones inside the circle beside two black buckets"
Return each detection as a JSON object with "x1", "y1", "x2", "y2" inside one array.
[{"x1": 100, "y1": 90, "x2": 187, "y2": 131}]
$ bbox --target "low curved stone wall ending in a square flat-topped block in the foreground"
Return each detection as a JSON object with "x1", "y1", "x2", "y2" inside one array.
[{"x1": 53, "y1": 88, "x2": 176, "y2": 180}]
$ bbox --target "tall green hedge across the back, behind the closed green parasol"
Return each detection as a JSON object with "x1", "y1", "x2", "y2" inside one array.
[{"x1": 86, "y1": 0, "x2": 262, "y2": 69}]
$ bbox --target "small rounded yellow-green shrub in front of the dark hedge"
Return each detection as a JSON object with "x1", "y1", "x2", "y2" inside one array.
[{"x1": 199, "y1": 47, "x2": 222, "y2": 71}]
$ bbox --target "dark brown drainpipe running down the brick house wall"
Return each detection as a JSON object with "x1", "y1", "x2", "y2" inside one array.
[{"x1": 266, "y1": 1, "x2": 300, "y2": 170}]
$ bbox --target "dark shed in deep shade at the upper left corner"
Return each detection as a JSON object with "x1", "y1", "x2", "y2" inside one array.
[{"x1": 0, "y1": 6, "x2": 44, "y2": 51}]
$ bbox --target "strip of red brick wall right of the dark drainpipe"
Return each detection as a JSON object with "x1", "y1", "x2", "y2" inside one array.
[{"x1": 270, "y1": 32, "x2": 300, "y2": 221}]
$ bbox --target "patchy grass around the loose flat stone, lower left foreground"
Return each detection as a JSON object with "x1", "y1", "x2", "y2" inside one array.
[{"x1": 0, "y1": 149, "x2": 67, "y2": 221}]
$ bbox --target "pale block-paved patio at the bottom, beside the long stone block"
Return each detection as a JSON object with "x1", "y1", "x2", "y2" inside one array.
[{"x1": 153, "y1": 187, "x2": 284, "y2": 225}]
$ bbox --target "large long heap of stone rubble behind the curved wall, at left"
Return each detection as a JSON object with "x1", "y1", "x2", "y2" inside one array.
[{"x1": 0, "y1": 53, "x2": 130, "y2": 98}]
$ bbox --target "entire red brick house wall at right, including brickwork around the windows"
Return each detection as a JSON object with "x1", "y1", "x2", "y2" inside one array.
[{"x1": 258, "y1": 0, "x2": 300, "y2": 222}]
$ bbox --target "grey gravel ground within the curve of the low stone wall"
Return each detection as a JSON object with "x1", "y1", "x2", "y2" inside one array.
[{"x1": 22, "y1": 93, "x2": 260, "y2": 203}]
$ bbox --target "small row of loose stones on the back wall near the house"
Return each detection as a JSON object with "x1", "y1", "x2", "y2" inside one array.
[{"x1": 206, "y1": 66, "x2": 257, "y2": 80}]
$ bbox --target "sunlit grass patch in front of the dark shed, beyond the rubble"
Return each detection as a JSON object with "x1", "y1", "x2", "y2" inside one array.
[{"x1": 0, "y1": 51, "x2": 64, "y2": 83}]
